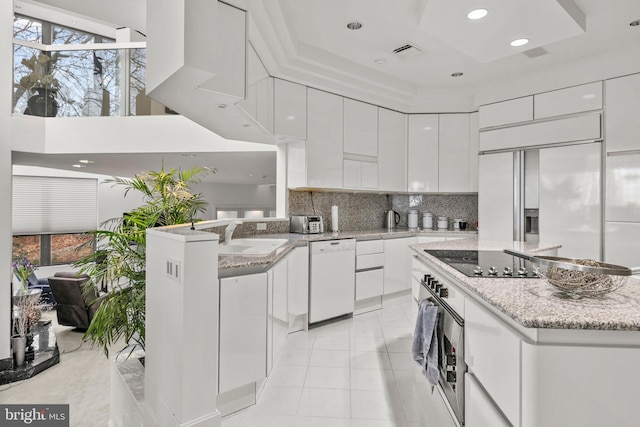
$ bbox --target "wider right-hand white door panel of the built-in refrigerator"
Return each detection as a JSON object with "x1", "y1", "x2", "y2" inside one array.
[{"x1": 539, "y1": 143, "x2": 602, "y2": 260}]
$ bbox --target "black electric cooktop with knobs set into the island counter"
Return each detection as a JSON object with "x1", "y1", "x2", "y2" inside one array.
[{"x1": 424, "y1": 249, "x2": 538, "y2": 279}]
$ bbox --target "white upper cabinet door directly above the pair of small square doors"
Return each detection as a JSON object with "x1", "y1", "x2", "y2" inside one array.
[{"x1": 344, "y1": 98, "x2": 378, "y2": 157}]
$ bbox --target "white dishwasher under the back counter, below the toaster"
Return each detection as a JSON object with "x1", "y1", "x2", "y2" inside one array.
[{"x1": 309, "y1": 239, "x2": 356, "y2": 323}]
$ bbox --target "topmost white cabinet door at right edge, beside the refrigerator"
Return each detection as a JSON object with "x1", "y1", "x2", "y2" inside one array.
[{"x1": 605, "y1": 74, "x2": 640, "y2": 152}]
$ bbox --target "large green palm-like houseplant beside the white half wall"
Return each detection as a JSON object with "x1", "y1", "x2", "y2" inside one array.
[{"x1": 76, "y1": 166, "x2": 210, "y2": 357}]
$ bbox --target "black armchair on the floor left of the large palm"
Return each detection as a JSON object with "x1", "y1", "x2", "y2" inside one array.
[{"x1": 49, "y1": 272, "x2": 105, "y2": 330}]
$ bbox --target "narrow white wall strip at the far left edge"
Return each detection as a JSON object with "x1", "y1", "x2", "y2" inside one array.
[{"x1": 0, "y1": 1, "x2": 13, "y2": 360}]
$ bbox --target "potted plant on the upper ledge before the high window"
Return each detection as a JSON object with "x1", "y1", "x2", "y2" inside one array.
[{"x1": 20, "y1": 52, "x2": 60, "y2": 117}]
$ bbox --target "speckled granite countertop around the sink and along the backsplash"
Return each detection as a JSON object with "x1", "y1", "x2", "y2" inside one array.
[{"x1": 218, "y1": 228, "x2": 477, "y2": 277}]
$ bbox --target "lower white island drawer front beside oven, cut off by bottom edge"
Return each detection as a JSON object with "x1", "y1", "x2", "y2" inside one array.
[{"x1": 464, "y1": 373, "x2": 511, "y2": 427}]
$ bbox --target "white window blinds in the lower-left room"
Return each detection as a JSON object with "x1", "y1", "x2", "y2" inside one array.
[{"x1": 12, "y1": 175, "x2": 98, "y2": 234}]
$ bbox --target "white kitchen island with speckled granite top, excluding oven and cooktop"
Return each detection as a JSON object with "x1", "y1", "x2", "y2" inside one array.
[{"x1": 411, "y1": 239, "x2": 640, "y2": 427}]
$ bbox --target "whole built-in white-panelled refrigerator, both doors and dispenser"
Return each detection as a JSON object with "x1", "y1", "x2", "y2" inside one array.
[{"x1": 478, "y1": 141, "x2": 602, "y2": 260}]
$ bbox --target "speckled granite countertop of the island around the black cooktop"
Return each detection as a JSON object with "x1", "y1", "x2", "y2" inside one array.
[{"x1": 411, "y1": 239, "x2": 640, "y2": 331}]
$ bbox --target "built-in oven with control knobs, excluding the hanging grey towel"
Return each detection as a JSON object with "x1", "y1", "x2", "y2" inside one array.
[{"x1": 418, "y1": 274, "x2": 467, "y2": 425}]
